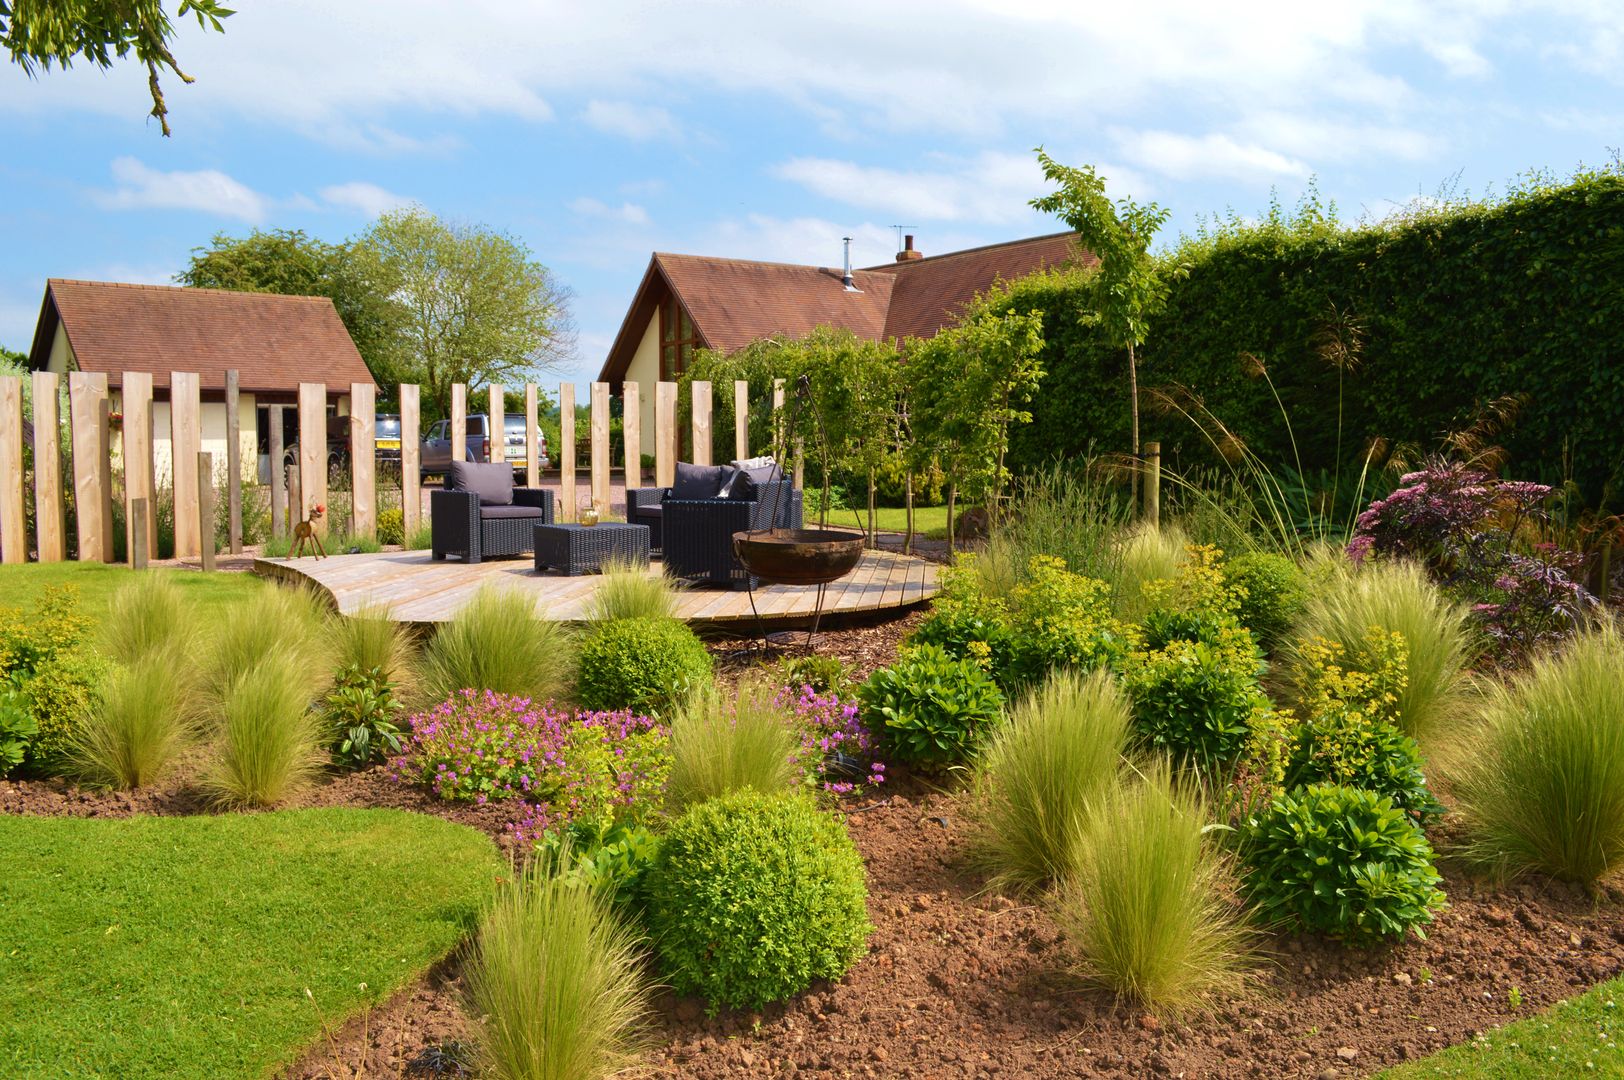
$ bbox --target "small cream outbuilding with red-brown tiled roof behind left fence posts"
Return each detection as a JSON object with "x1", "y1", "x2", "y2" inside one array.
[{"x1": 28, "y1": 278, "x2": 372, "y2": 477}]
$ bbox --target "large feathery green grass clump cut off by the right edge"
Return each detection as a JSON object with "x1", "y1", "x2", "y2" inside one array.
[{"x1": 1449, "y1": 622, "x2": 1624, "y2": 887}]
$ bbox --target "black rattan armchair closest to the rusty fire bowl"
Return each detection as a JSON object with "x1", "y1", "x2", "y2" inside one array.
[{"x1": 659, "y1": 481, "x2": 802, "y2": 590}]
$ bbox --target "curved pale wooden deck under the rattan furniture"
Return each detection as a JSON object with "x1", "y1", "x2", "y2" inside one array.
[{"x1": 253, "y1": 551, "x2": 939, "y2": 632}]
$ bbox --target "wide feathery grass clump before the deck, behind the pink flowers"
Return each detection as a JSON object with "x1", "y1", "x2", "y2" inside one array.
[{"x1": 421, "y1": 585, "x2": 575, "y2": 702}]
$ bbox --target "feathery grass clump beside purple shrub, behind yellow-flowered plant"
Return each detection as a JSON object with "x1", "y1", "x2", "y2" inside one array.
[{"x1": 1286, "y1": 560, "x2": 1475, "y2": 744}]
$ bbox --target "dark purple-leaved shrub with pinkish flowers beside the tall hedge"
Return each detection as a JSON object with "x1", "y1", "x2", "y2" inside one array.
[{"x1": 1348, "y1": 461, "x2": 1596, "y2": 659}]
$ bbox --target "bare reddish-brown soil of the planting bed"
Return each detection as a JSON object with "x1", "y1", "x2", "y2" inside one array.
[{"x1": 0, "y1": 616, "x2": 1624, "y2": 1080}]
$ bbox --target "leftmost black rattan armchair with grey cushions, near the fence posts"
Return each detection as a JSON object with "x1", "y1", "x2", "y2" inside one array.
[{"x1": 429, "y1": 461, "x2": 552, "y2": 562}]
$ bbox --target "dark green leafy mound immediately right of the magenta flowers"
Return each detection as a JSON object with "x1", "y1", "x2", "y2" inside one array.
[{"x1": 857, "y1": 645, "x2": 1004, "y2": 767}]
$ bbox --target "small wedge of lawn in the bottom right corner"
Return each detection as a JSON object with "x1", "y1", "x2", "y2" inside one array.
[{"x1": 1382, "y1": 979, "x2": 1624, "y2": 1080}]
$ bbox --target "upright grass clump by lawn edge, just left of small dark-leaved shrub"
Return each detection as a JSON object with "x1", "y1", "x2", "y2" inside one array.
[{"x1": 201, "y1": 650, "x2": 325, "y2": 807}]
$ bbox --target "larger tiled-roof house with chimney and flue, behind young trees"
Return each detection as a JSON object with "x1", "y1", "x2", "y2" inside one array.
[{"x1": 598, "y1": 232, "x2": 1095, "y2": 430}]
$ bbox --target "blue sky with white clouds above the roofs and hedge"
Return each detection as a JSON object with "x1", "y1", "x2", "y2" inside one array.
[{"x1": 0, "y1": 0, "x2": 1624, "y2": 391}]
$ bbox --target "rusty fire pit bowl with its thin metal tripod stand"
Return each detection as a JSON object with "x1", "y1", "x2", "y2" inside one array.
[{"x1": 732, "y1": 375, "x2": 864, "y2": 646}]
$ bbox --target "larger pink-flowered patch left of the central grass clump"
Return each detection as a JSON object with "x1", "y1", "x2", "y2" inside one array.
[{"x1": 390, "y1": 690, "x2": 671, "y2": 833}]
